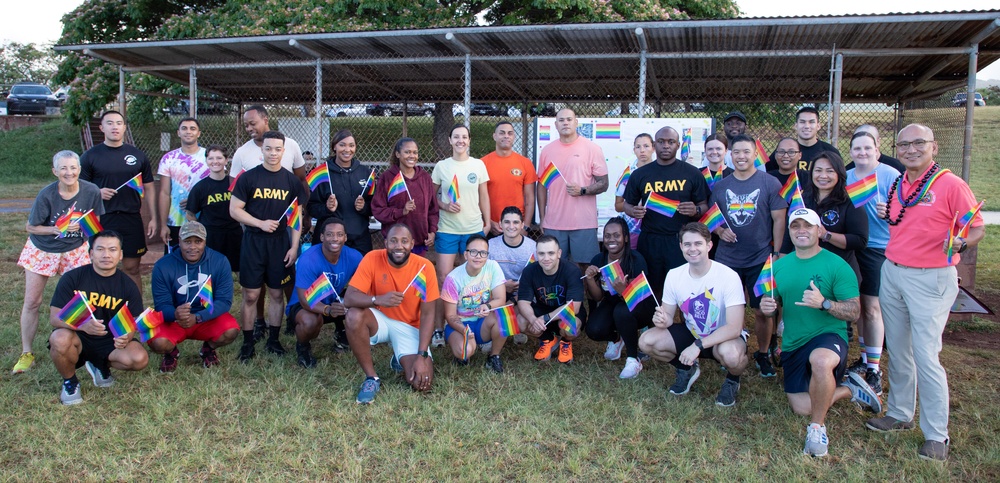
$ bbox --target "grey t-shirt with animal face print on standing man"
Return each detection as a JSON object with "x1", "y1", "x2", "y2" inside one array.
[{"x1": 708, "y1": 170, "x2": 788, "y2": 268}]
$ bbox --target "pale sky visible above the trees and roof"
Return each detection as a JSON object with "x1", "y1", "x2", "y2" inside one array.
[{"x1": 0, "y1": 0, "x2": 1000, "y2": 79}]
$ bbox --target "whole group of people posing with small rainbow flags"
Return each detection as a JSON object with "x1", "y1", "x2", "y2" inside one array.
[{"x1": 14, "y1": 106, "x2": 984, "y2": 466}]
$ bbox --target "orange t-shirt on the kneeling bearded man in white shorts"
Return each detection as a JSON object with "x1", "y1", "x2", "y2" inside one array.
[{"x1": 349, "y1": 250, "x2": 439, "y2": 329}]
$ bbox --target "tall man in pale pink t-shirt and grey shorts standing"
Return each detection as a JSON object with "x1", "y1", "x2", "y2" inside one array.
[{"x1": 537, "y1": 108, "x2": 608, "y2": 266}]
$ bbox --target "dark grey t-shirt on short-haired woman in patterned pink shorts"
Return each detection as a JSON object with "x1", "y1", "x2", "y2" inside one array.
[{"x1": 28, "y1": 179, "x2": 104, "y2": 253}]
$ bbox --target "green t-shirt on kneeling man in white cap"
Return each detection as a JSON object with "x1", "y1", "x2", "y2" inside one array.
[{"x1": 774, "y1": 249, "x2": 858, "y2": 351}]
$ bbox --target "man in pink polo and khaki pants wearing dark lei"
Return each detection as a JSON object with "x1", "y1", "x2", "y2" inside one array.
[{"x1": 866, "y1": 124, "x2": 986, "y2": 461}]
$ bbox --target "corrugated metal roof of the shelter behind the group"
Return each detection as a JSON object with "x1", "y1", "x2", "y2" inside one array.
[{"x1": 56, "y1": 10, "x2": 1000, "y2": 103}]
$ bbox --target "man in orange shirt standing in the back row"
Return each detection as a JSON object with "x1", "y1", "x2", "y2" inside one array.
[{"x1": 482, "y1": 121, "x2": 538, "y2": 238}]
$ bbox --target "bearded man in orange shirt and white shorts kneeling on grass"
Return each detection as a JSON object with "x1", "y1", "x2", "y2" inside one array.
[{"x1": 344, "y1": 224, "x2": 439, "y2": 404}]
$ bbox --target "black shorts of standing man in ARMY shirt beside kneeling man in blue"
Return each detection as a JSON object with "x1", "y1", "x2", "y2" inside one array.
[{"x1": 240, "y1": 232, "x2": 294, "y2": 288}]
